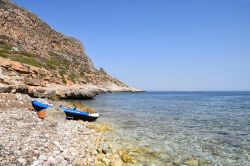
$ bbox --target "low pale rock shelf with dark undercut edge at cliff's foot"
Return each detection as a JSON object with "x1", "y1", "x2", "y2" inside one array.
[{"x1": 0, "y1": 83, "x2": 143, "y2": 100}]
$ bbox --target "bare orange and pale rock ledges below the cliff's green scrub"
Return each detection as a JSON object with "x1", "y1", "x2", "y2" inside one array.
[{"x1": 0, "y1": 57, "x2": 142, "y2": 99}]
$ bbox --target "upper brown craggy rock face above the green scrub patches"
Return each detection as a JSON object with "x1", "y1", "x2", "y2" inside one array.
[{"x1": 0, "y1": 0, "x2": 96, "y2": 71}]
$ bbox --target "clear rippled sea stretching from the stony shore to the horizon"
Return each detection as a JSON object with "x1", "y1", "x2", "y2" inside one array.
[{"x1": 80, "y1": 92, "x2": 250, "y2": 165}]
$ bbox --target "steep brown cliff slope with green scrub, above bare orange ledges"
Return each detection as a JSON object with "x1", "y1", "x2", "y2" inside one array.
[{"x1": 0, "y1": 0, "x2": 126, "y2": 87}]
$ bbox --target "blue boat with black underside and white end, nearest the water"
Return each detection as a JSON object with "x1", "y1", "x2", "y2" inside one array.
[{"x1": 59, "y1": 105, "x2": 99, "y2": 121}]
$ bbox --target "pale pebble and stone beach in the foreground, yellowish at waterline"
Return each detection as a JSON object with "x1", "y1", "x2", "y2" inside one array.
[{"x1": 0, "y1": 93, "x2": 137, "y2": 166}]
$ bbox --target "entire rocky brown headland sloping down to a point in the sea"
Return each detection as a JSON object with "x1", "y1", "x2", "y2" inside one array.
[{"x1": 0, "y1": 0, "x2": 141, "y2": 98}]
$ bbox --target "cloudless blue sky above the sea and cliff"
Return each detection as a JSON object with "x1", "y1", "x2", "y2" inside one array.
[{"x1": 14, "y1": 0, "x2": 250, "y2": 90}]
